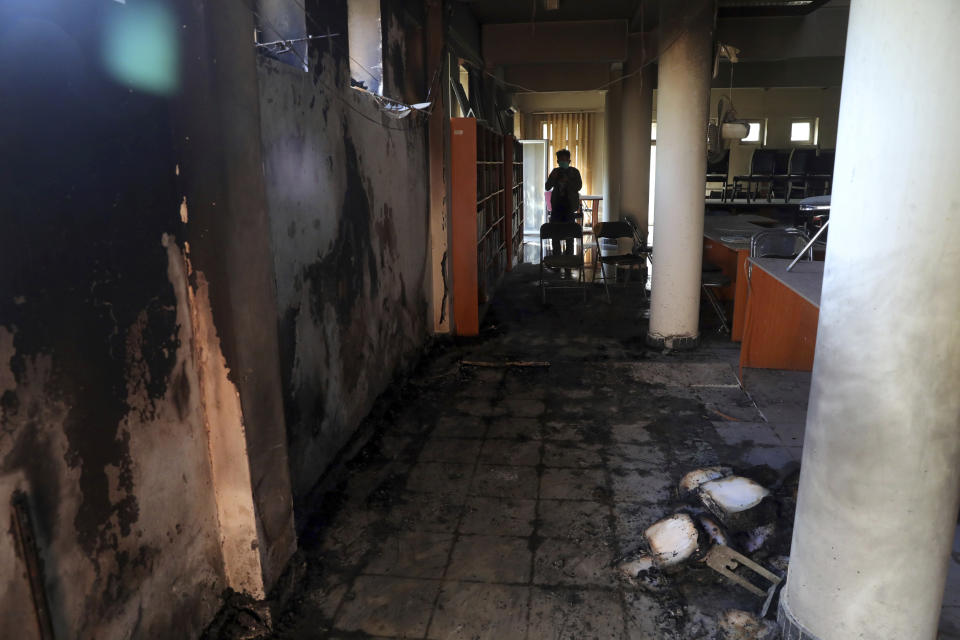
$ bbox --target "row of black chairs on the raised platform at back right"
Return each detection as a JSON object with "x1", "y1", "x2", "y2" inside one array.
[{"x1": 706, "y1": 148, "x2": 834, "y2": 202}]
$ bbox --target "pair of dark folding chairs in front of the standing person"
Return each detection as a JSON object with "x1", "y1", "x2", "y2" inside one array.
[{"x1": 540, "y1": 218, "x2": 650, "y2": 302}]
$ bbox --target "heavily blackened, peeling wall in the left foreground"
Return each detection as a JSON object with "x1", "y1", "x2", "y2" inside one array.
[{"x1": 0, "y1": 0, "x2": 225, "y2": 639}]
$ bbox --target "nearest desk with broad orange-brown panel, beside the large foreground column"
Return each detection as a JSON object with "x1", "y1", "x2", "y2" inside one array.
[{"x1": 740, "y1": 258, "x2": 823, "y2": 371}]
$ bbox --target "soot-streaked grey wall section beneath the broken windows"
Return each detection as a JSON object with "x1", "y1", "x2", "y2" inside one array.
[{"x1": 259, "y1": 0, "x2": 429, "y2": 500}]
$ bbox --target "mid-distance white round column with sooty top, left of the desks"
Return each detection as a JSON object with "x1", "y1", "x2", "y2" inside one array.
[{"x1": 647, "y1": 3, "x2": 714, "y2": 349}]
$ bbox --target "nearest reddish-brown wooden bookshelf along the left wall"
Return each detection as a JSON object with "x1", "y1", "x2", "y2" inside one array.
[{"x1": 451, "y1": 118, "x2": 523, "y2": 335}]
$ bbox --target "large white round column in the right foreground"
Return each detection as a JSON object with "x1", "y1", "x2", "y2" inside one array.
[{"x1": 780, "y1": 0, "x2": 960, "y2": 640}]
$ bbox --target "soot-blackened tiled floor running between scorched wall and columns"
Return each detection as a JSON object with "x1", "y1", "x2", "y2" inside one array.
[{"x1": 277, "y1": 262, "x2": 960, "y2": 640}]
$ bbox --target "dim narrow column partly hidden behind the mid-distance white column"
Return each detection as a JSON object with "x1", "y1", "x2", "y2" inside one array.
[{"x1": 620, "y1": 60, "x2": 654, "y2": 232}]
